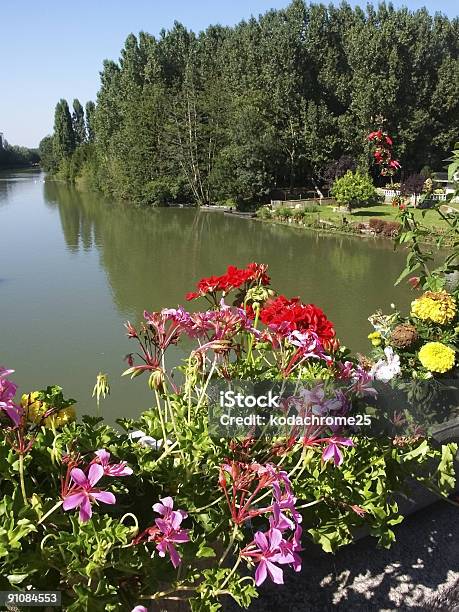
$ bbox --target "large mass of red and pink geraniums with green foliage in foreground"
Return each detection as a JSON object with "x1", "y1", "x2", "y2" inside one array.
[{"x1": 0, "y1": 263, "x2": 455, "y2": 612}]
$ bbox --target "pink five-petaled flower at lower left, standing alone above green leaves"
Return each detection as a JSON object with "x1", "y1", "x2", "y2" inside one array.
[{"x1": 62, "y1": 463, "x2": 116, "y2": 523}]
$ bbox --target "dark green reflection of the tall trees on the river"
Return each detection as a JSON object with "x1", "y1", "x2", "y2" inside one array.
[{"x1": 45, "y1": 183, "x2": 410, "y2": 342}]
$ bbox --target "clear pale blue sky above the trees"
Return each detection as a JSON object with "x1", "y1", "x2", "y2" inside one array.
[{"x1": 0, "y1": 0, "x2": 459, "y2": 146}]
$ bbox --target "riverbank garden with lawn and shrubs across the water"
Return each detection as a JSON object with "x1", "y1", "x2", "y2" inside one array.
[{"x1": 257, "y1": 134, "x2": 458, "y2": 242}]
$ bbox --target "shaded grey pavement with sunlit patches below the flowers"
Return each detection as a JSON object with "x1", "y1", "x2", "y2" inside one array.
[{"x1": 224, "y1": 502, "x2": 459, "y2": 612}]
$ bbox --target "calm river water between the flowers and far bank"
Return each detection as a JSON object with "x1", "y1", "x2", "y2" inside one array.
[{"x1": 0, "y1": 171, "x2": 410, "y2": 420}]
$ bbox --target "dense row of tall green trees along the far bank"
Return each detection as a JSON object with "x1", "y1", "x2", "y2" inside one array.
[{"x1": 40, "y1": 0, "x2": 459, "y2": 204}]
